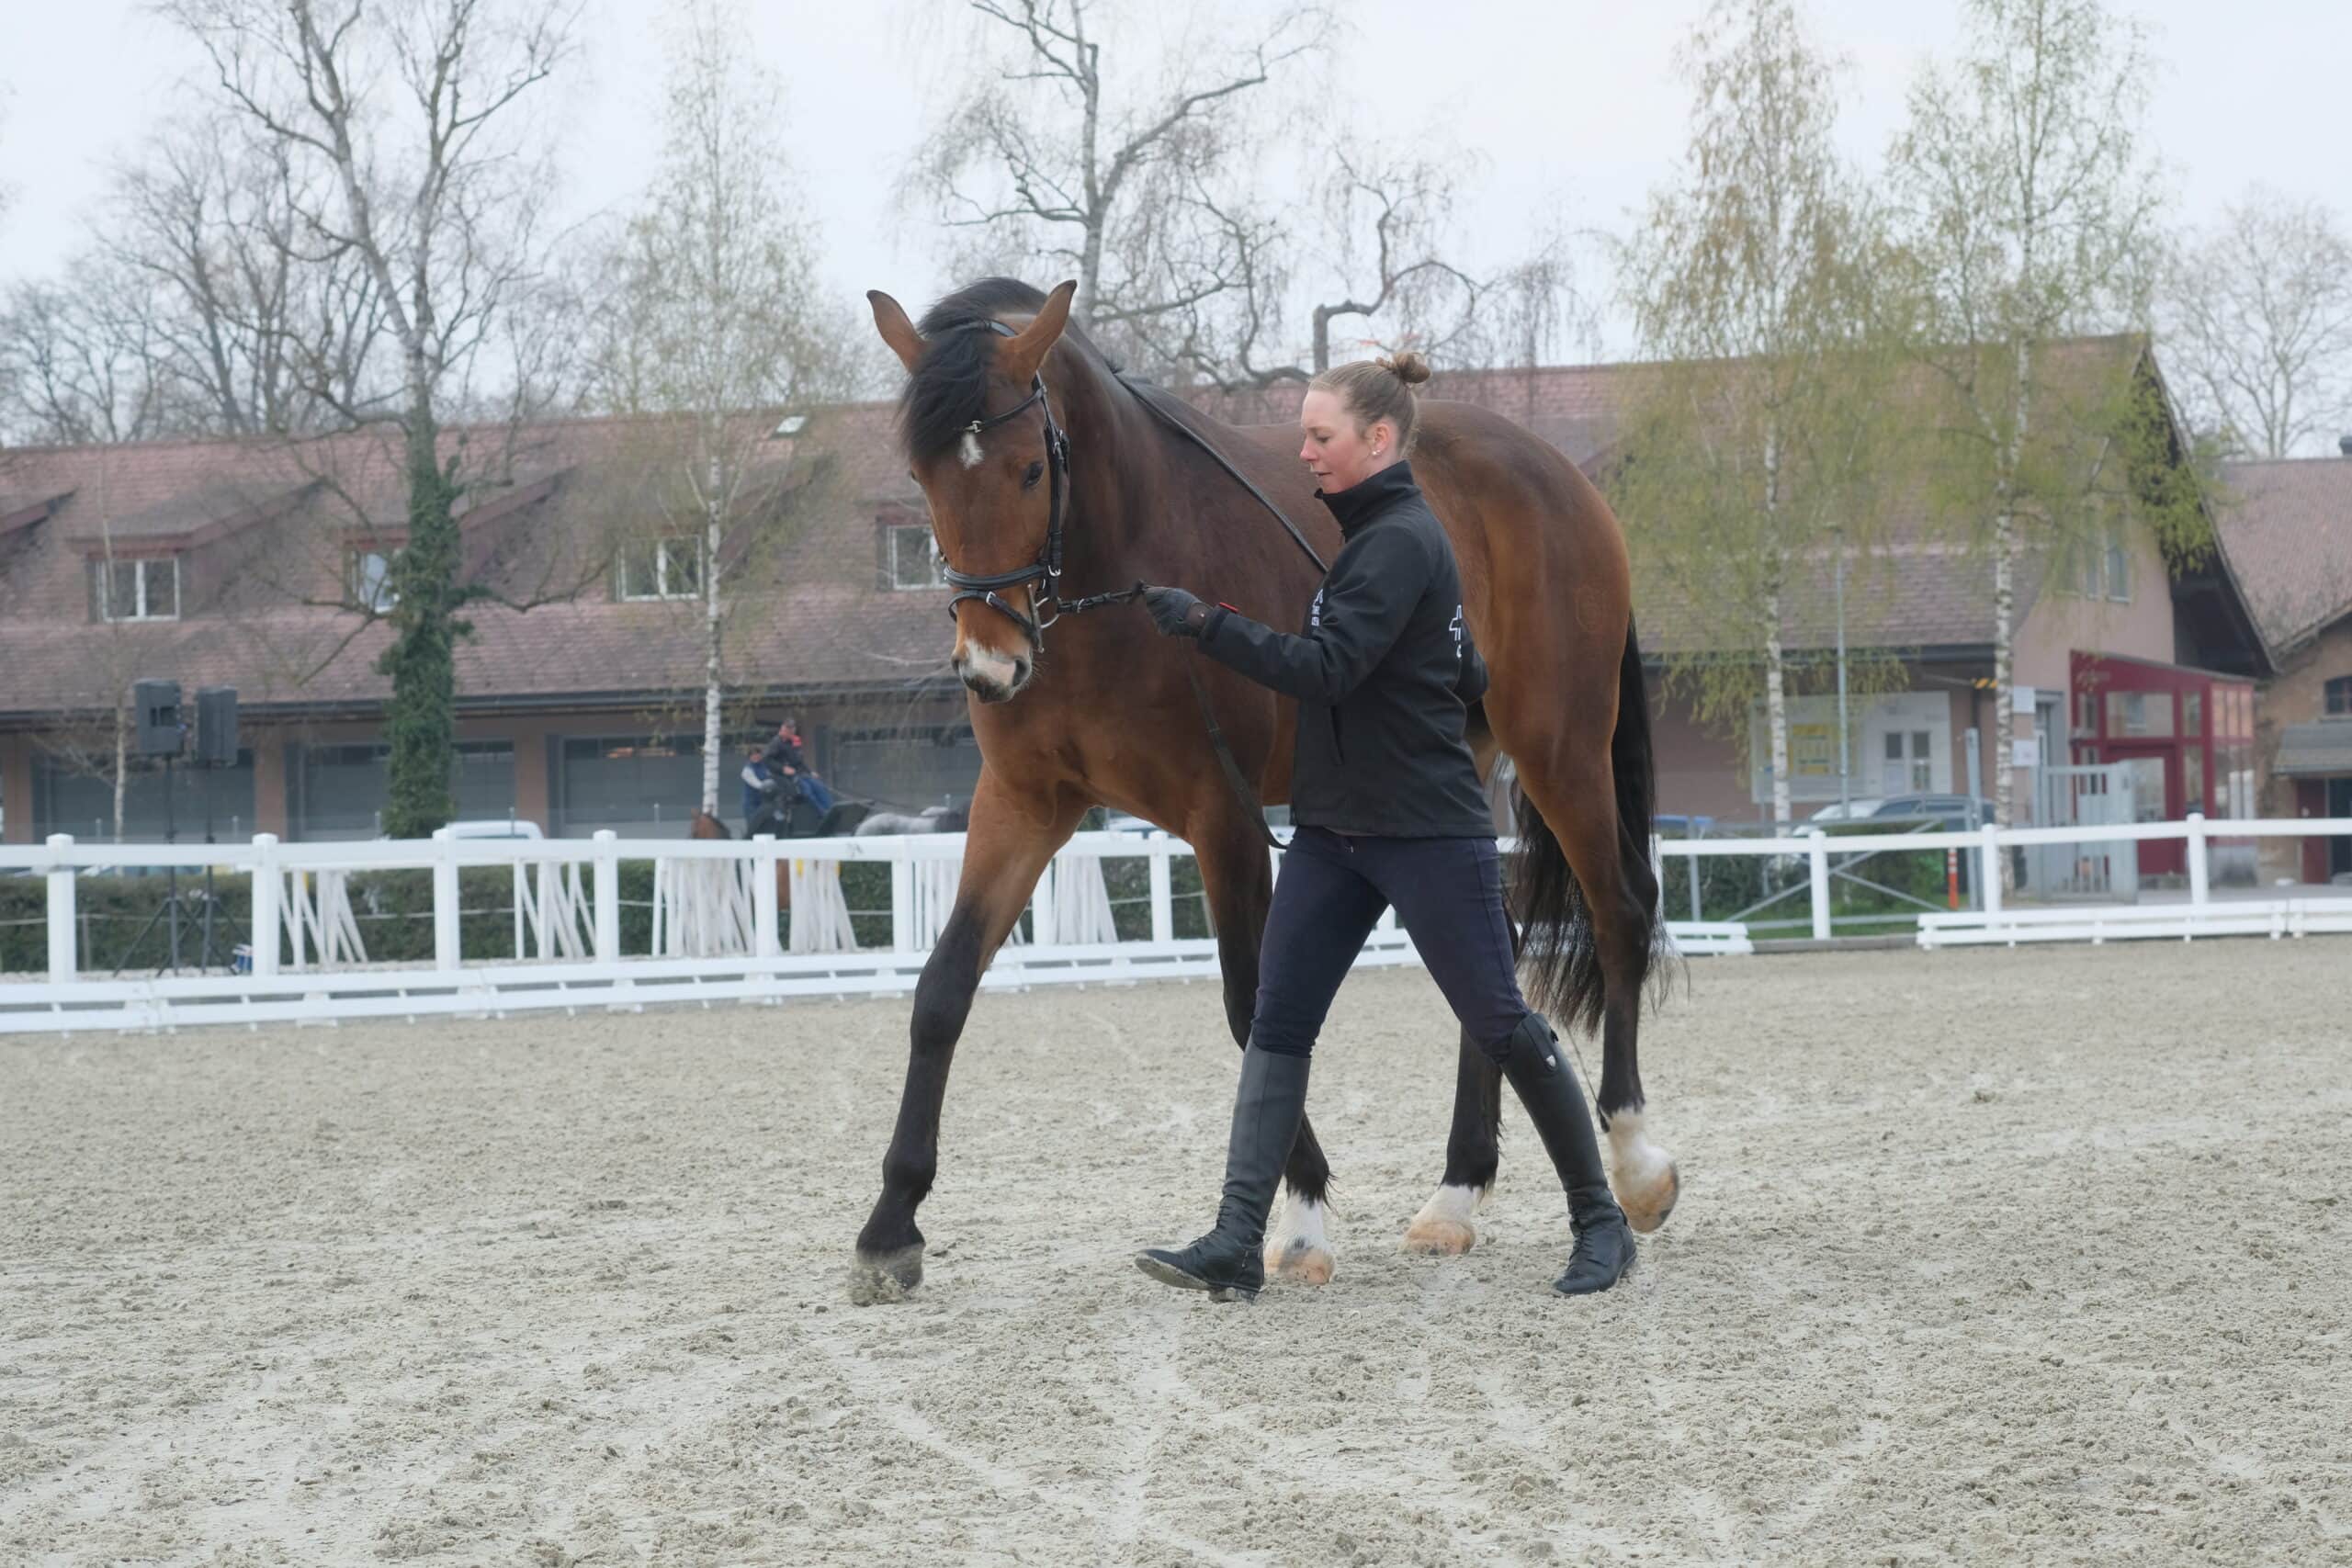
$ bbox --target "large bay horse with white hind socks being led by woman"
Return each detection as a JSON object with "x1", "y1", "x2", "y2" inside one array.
[{"x1": 852, "y1": 277, "x2": 1679, "y2": 1303}]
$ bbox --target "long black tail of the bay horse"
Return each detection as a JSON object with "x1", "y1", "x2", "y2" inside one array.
[{"x1": 1512, "y1": 618, "x2": 1658, "y2": 1030}]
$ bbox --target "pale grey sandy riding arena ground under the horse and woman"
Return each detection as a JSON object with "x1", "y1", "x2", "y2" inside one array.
[{"x1": 0, "y1": 938, "x2": 2352, "y2": 1568}]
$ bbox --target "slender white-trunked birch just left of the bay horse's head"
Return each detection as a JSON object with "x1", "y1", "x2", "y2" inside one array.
[{"x1": 593, "y1": 0, "x2": 854, "y2": 813}]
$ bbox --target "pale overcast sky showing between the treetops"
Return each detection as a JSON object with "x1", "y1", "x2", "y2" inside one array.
[{"x1": 0, "y1": 0, "x2": 2352, "y2": 359}]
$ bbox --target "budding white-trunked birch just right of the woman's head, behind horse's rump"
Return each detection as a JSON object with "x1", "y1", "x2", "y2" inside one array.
[{"x1": 1611, "y1": 0, "x2": 1886, "y2": 829}]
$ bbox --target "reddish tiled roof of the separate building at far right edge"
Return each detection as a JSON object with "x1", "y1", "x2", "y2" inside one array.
[{"x1": 2221, "y1": 456, "x2": 2352, "y2": 649}]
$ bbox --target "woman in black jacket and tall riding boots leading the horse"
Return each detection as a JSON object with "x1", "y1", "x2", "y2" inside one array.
[{"x1": 1136, "y1": 353, "x2": 1634, "y2": 1300}]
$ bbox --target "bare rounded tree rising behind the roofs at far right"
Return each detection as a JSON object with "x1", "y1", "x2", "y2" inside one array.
[{"x1": 2162, "y1": 186, "x2": 2352, "y2": 458}]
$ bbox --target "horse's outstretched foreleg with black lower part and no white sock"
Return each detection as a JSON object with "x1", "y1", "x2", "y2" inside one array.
[{"x1": 849, "y1": 773, "x2": 1084, "y2": 1304}]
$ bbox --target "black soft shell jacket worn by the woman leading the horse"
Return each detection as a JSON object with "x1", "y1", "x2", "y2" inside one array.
[{"x1": 1200, "y1": 463, "x2": 1494, "y2": 840}]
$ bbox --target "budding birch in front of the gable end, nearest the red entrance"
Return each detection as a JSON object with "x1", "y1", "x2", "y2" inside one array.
[{"x1": 1889, "y1": 0, "x2": 2197, "y2": 846}]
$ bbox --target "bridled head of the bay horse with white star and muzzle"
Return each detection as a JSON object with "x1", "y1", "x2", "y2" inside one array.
[{"x1": 865, "y1": 282, "x2": 1077, "y2": 703}]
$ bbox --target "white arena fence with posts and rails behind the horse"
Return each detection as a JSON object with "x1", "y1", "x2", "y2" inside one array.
[{"x1": 0, "y1": 816, "x2": 2352, "y2": 1032}]
